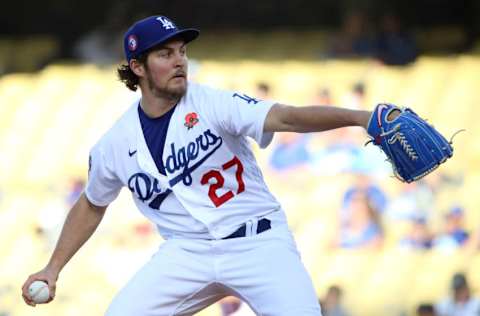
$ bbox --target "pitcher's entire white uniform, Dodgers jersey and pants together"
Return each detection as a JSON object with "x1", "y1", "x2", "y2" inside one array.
[{"x1": 85, "y1": 83, "x2": 321, "y2": 316}]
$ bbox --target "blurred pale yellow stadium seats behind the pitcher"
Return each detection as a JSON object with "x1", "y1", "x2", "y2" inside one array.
[{"x1": 0, "y1": 55, "x2": 480, "y2": 316}]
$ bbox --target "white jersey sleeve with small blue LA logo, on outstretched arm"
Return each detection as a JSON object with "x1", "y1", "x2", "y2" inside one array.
[{"x1": 208, "y1": 91, "x2": 275, "y2": 148}]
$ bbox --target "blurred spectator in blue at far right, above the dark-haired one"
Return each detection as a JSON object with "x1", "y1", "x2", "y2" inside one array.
[{"x1": 433, "y1": 206, "x2": 469, "y2": 249}]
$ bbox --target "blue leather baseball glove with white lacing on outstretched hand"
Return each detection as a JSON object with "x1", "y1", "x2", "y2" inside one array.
[{"x1": 367, "y1": 103, "x2": 453, "y2": 183}]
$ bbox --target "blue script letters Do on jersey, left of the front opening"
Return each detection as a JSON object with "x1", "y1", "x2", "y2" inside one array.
[{"x1": 128, "y1": 172, "x2": 172, "y2": 210}]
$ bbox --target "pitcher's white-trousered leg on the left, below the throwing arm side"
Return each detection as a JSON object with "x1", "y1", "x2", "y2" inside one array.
[{"x1": 106, "y1": 240, "x2": 227, "y2": 316}]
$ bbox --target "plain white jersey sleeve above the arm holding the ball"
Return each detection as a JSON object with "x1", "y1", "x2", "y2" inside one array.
[{"x1": 85, "y1": 145, "x2": 123, "y2": 206}]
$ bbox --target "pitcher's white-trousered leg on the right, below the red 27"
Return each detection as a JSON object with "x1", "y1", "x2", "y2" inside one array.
[{"x1": 221, "y1": 226, "x2": 321, "y2": 316}]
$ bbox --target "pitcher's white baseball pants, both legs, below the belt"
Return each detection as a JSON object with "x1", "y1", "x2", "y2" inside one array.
[{"x1": 106, "y1": 217, "x2": 321, "y2": 316}]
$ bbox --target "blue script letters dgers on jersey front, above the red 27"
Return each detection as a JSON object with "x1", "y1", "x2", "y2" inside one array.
[{"x1": 165, "y1": 129, "x2": 223, "y2": 187}]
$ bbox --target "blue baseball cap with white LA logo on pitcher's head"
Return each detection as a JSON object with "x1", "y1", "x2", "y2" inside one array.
[{"x1": 123, "y1": 15, "x2": 200, "y2": 62}]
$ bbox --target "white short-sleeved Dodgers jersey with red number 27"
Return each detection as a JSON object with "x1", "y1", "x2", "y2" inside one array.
[{"x1": 85, "y1": 83, "x2": 283, "y2": 239}]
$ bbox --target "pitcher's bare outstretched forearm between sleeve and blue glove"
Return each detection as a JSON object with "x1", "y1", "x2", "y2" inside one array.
[{"x1": 263, "y1": 103, "x2": 372, "y2": 133}]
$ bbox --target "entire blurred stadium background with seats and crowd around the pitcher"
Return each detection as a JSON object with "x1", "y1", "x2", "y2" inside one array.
[{"x1": 0, "y1": 0, "x2": 480, "y2": 316}]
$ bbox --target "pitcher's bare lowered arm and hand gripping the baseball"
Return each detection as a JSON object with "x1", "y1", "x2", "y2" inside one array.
[{"x1": 22, "y1": 194, "x2": 107, "y2": 306}]
